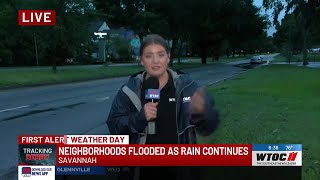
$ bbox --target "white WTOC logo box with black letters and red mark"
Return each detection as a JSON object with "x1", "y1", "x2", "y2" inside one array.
[{"x1": 252, "y1": 151, "x2": 302, "y2": 166}]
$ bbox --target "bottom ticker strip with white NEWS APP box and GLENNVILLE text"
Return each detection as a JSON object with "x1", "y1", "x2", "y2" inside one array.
[{"x1": 18, "y1": 166, "x2": 301, "y2": 180}]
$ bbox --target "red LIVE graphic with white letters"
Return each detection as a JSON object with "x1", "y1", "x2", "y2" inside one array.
[{"x1": 18, "y1": 10, "x2": 56, "y2": 26}]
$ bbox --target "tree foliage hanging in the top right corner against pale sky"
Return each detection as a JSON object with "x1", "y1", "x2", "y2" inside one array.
[{"x1": 263, "y1": 0, "x2": 320, "y2": 65}]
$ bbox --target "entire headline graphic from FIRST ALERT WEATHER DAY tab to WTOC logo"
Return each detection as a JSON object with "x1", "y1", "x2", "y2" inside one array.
[{"x1": 18, "y1": 135, "x2": 302, "y2": 166}]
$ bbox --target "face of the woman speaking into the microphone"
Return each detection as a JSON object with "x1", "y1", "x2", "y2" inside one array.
[{"x1": 141, "y1": 44, "x2": 170, "y2": 77}]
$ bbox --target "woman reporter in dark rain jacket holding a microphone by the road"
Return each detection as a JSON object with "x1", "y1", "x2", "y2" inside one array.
[{"x1": 107, "y1": 34, "x2": 219, "y2": 179}]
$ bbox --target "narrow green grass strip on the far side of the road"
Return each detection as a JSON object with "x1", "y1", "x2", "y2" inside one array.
[{"x1": 0, "y1": 62, "x2": 210, "y2": 88}]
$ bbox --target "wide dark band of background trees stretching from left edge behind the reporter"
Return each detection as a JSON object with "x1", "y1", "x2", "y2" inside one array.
[{"x1": 0, "y1": 0, "x2": 270, "y2": 69}]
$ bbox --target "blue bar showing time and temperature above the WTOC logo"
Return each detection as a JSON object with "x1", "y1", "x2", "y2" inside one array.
[{"x1": 252, "y1": 144, "x2": 302, "y2": 151}]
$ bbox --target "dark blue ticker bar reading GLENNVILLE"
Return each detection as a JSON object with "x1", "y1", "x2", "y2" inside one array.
[{"x1": 56, "y1": 166, "x2": 106, "y2": 175}]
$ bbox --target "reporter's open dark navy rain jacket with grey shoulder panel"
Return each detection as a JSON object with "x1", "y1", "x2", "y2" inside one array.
[{"x1": 107, "y1": 69, "x2": 219, "y2": 177}]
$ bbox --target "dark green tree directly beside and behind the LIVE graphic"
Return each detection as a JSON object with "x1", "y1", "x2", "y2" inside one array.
[{"x1": 45, "y1": 0, "x2": 95, "y2": 72}]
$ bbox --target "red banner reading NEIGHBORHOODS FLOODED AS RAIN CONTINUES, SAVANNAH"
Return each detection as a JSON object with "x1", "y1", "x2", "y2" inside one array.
[{"x1": 56, "y1": 144, "x2": 252, "y2": 166}]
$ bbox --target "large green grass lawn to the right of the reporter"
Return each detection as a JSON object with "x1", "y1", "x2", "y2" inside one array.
[{"x1": 200, "y1": 65, "x2": 320, "y2": 179}]
